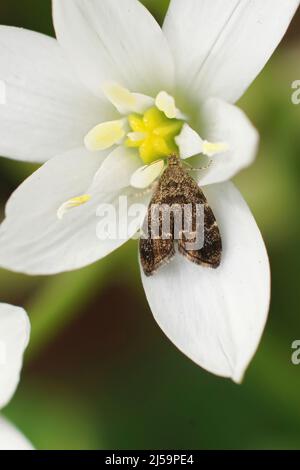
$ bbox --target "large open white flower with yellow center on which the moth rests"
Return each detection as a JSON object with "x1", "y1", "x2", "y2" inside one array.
[{"x1": 0, "y1": 0, "x2": 299, "y2": 381}]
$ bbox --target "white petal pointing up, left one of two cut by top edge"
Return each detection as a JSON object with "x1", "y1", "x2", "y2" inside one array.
[{"x1": 53, "y1": 0, "x2": 174, "y2": 96}]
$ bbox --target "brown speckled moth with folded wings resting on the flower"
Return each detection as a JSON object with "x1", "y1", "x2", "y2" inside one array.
[{"x1": 140, "y1": 155, "x2": 222, "y2": 276}]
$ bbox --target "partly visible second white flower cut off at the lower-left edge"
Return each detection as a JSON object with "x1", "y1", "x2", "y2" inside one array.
[{"x1": 0, "y1": 303, "x2": 32, "y2": 450}]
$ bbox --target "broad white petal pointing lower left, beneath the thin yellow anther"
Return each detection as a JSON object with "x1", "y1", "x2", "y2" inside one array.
[{"x1": 0, "y1": 149, "x2": 149, "y2": 274}]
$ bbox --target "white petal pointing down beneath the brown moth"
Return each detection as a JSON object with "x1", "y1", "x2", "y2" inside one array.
[{"x1": 142, "y1": 183, "x2": 270, "y2": 382}]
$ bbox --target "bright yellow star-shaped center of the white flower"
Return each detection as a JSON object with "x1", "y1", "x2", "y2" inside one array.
[{"x1": 125, "y1": 107, "x2": 183, "y2": 164}]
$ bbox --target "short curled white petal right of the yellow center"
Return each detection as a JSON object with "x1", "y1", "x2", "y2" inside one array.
[{"x1": 199, "y1": 98, "x2": 259, "y2": 186}]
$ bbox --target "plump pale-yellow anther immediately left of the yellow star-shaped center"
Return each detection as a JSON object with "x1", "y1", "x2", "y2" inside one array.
[{"x1": 84, "y1": 119, "x2": 126, "y2": 151}]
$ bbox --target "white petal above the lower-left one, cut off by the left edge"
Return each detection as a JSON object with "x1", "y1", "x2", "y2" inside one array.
[{"x1": 0, "y1": 26, "x2": 111, "y2": 162}]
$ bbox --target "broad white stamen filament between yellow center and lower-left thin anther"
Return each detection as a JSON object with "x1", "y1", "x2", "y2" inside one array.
[{"x1": 87, "y1": 146, "x2": 142, "y2": 194}]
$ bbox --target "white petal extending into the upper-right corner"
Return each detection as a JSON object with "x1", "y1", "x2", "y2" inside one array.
[{"x1": 163, "y1": 0, "x2": 299, "y2": 103}]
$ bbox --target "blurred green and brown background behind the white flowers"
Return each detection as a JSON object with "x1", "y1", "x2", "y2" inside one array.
[{"x1": 0, "y1": 0, "x2": 300, "y2": 449}]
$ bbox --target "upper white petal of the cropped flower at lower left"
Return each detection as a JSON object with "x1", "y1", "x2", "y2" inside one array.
[{"x1": 0, "y1": 303, "x2": 30, "y2": 410}]
